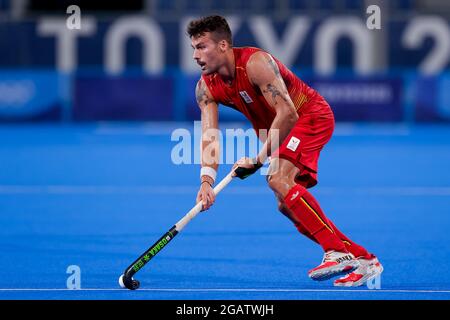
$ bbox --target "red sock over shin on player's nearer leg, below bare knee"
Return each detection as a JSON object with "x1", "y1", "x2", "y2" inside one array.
[{"x1": 284, "y1": 184, "x2": 348, "y2": 252}]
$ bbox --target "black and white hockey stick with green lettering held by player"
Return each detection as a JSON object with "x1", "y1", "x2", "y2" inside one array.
[{"x1": 119, "y1": 171, "x2": 233, "y2": 290}]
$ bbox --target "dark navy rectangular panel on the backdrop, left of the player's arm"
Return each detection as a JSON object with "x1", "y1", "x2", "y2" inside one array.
[{"x1": 73, "y1": 75, "x2": 175, "y2": 121}]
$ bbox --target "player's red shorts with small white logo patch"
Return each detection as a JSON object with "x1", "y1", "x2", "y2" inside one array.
[{"x1": 272, "y1": 101, "x2": 334, "y2": 188}]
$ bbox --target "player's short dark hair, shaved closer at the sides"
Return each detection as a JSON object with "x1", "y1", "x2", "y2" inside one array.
[{"x1": 187, "y1": 16, "x2": 233, "y2": 46}]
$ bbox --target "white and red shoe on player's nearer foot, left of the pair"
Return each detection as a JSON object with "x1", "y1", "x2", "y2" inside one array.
[{"x1": 308, "y1": 251, "x2": 359, "y2": 281}]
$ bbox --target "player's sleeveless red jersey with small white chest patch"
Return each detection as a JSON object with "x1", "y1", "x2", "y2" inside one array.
[{"x1": 202, "y1": 47, "x2": 331, "y2": 134}]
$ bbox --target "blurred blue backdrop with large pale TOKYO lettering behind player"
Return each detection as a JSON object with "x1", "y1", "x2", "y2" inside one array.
[{"x1": 0, "y1": 0, "x2": 450, "y2": 123}]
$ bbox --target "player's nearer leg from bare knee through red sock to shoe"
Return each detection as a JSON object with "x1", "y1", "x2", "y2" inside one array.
[{"x1": 268, "y1": 158, "x2": 360, "y2": 280}]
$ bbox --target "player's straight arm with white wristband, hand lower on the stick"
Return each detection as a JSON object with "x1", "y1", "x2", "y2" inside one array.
[{"x1": 195, "y1": 79, "x2": 220, "y2": 210}]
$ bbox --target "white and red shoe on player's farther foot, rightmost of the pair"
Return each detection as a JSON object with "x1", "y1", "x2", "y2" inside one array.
[{"x1": 333, "y1": 256, "x2": 383, "y2": 287}]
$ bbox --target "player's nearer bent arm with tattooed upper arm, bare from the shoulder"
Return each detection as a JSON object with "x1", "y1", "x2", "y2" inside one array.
[{"x1": 235, "y1": 52, "x2": 298, "y2": 177}]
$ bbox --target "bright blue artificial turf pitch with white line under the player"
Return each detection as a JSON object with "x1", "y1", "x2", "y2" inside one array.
[{"x1": 0, "y1": 123, "x2": 450, "y2": 300}]
